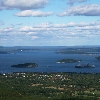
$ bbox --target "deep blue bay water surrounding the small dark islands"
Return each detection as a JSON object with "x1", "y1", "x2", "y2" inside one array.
[{"x1": 0, "y1": 47, "x2": 100, "y2": 73}]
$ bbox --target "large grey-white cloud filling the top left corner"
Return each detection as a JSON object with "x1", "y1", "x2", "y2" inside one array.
[{"x1": 0, "y1": 0, "x2": 48, "y2": 10}]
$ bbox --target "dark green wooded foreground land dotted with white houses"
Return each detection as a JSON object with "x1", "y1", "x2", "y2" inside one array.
[{"x1": 0, "y1": 72, "x2": 100, "y2": 100}]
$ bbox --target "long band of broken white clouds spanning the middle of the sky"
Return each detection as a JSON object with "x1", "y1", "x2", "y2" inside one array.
[{"x1": 0, "y1": 21, "x2": 100, "y2": 36}]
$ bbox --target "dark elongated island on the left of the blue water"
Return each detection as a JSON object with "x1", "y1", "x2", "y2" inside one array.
[{"x1": 11, "y1": 63, "x2": 38, "y2": 68}]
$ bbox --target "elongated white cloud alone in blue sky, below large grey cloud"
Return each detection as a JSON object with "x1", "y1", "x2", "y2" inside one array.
[{"x1": 15, "y1": 10, "x2": 53, "y2": 17}]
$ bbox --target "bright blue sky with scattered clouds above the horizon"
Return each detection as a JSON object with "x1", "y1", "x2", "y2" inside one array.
[{"x1": 0, "y1": 0, "x2": 100, "y2": 46}]
